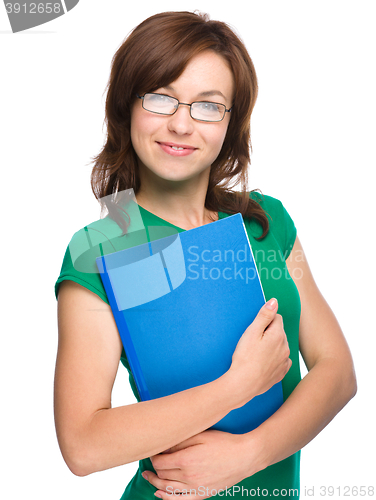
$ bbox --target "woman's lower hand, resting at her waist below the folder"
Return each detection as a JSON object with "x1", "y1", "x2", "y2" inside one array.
[{"x1": 143, "y1": 430, "x2": 260, "y2": 500}]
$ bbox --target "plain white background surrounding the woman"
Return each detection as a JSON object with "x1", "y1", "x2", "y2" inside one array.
[{"x1": 0, "y1": 0, "x2": 376, "y2": 500}]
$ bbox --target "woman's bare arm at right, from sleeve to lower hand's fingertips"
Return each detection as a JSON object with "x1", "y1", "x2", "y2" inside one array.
[{"x1": 147, "y1": 239, "x2": 356, "y2": 500}]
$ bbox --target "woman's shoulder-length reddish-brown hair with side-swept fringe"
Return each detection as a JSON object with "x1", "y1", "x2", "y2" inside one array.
[{"x1": 91, "y1": 12, "x2": 269, "y2": 237}]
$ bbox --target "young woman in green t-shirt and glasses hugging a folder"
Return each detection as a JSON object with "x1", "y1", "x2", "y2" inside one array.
[{"x1": 55, "y1": 12, "x2": 356, "y2": 500}]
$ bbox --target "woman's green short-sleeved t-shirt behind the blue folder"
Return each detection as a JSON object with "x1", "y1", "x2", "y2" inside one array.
[{"x1": 55, "y1": 192, "x2": 301, "y2": 500}]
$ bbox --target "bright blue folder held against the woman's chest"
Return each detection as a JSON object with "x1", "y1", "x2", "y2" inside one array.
[{"x1": 96, "y1": 214, "x2": 283, "y2": 434}]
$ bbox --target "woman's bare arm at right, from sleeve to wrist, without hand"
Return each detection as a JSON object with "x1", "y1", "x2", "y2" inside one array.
[{"x1": 252, "y1": 234, "x2": 357, "y2": 468}]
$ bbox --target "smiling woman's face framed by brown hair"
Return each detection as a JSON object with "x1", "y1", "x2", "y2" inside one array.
[{"x1": 131, "y1": 51, "x2": 234, "y2": 188}]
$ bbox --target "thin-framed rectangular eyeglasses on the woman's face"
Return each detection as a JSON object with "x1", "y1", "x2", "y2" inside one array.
[{"x1": 136, "y1": 93, "x2": 232, "y2": 122}]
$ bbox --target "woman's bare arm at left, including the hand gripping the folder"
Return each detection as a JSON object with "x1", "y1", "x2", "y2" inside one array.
[{"x1": 55, "y1": 281, "x2": 290, "y2": 475}]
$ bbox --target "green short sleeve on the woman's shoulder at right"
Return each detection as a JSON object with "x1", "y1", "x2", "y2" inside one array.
[{"x1": 250, "y1": 191, "x2": 297, "y2": 259}]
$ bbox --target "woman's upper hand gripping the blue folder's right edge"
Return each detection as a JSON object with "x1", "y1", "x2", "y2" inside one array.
[{"x1": 227, "y1": 299, "x2": 292, "y2": 407}]
